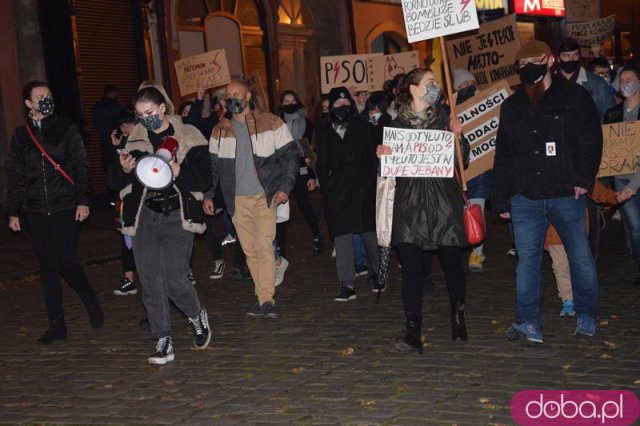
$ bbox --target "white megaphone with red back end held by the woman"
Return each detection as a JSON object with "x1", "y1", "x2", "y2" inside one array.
[{"x1": 134, "y1": 137, "x2": 178, "y2": 191}]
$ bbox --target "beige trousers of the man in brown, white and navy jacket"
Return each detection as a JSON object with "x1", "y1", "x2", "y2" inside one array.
[{"x1": 232, "y1": 194, "x2": 276, "y2": 305}]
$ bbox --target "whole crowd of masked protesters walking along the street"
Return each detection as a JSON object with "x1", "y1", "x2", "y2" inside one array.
[{"x1": 7, "y1": 35, "x2": 640, "y2": 364}]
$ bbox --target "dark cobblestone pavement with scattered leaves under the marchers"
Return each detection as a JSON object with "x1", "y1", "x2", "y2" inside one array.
[{"x1": 0, "y1": 195, "x2": 640, "y2": 425}]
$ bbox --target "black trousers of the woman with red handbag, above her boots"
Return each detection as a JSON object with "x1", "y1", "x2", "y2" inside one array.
[{"x1": 398, "y1": 243, "x2": 465, "y2": 315}]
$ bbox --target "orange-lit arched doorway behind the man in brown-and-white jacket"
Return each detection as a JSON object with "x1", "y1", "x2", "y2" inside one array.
[{"x1": 177, "y1": 0, "x2": 273, "y2": 104}]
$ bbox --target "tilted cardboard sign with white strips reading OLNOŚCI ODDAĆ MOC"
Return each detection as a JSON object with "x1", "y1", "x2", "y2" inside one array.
[{"x1": 457, "y1": 80, "x2": 512, "y2": 180}]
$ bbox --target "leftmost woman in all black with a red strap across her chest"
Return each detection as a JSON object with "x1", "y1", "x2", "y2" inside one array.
[{"x1": 6, "y1": 81, "x2": 104, "y2": 343}]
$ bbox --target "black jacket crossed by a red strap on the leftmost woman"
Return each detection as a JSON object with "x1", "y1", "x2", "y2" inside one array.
[{"x1": 6, "y1": 115, "x2": 91, "y2": 216}]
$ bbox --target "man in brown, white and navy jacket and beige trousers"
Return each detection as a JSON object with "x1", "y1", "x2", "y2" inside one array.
[{"x1": 203, "y1": 81, "x2": 300, "y2": 318}]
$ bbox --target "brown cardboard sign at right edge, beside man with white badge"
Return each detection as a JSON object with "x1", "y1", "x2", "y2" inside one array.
[{"x1": 598, "y1": 121, "x2": 640, "y2": 177}]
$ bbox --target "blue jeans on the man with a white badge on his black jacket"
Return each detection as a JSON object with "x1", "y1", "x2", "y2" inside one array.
[{"x1": 511, "y1": 195, "x2": 598, "y2": 326}]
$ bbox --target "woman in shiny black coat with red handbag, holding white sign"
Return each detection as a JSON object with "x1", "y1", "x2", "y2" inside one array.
[{"x1": 378, "y1": 69, "x2": 469, "y2": 353}]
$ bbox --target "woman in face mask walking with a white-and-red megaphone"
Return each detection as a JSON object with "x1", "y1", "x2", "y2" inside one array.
[{"x1": 109, "y1": 87, "x2": 212, "y2": 364}]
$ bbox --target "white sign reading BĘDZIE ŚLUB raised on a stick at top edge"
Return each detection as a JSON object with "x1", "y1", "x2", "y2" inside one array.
[{"x1": 402, "y1": 0, "x2": 478, "y2": 43}]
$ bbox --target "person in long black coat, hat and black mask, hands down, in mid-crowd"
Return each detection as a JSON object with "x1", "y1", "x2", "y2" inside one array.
[{"x1": 317, "y1": 87, "x2": 380, "y2": 302}]
